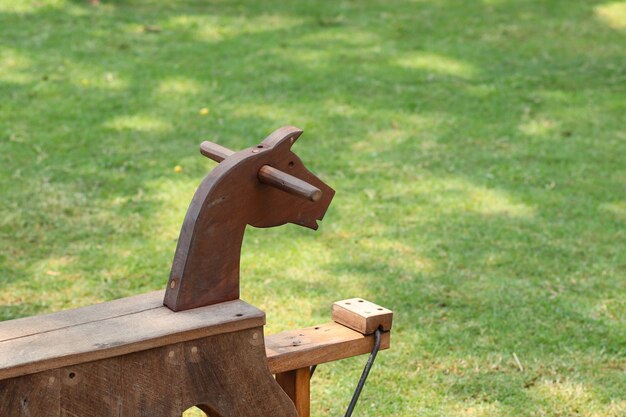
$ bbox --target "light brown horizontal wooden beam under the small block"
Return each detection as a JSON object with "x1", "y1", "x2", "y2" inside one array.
[{"x1": 265, "y1": 322, "x2": 390, "y2": 374}]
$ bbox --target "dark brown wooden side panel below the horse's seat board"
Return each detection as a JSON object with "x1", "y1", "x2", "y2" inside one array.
[{"x1": 0, "y1": 327, "x2": 297, "y2": 417}]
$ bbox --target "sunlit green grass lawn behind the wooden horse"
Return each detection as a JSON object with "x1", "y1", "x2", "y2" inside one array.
[{"x1": 0, "y1": 0, "x2": 626, "y2": 417}]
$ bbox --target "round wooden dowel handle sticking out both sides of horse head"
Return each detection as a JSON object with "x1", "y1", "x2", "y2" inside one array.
[{"x1": 200, "y1": 141, "x2": 322, "y2": 202}]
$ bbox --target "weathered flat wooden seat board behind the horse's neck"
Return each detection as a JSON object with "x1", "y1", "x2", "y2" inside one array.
[{"x1": 0, "y1": 291, "x2": 265, "y2": 380}]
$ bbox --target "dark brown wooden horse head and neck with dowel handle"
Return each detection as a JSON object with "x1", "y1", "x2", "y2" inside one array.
[{"x1": 164, "y1": 126, "x2": 335, "y2": 311}]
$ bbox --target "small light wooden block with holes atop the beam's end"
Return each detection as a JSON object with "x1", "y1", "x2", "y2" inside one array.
[{"x1": 332, "y1": 298, "x2": 393, "y2": 334}]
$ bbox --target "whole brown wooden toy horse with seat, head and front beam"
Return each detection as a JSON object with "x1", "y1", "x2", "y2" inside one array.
[{"x1": 0, "y1": 127, "x2": 392, "y2": 417}]
